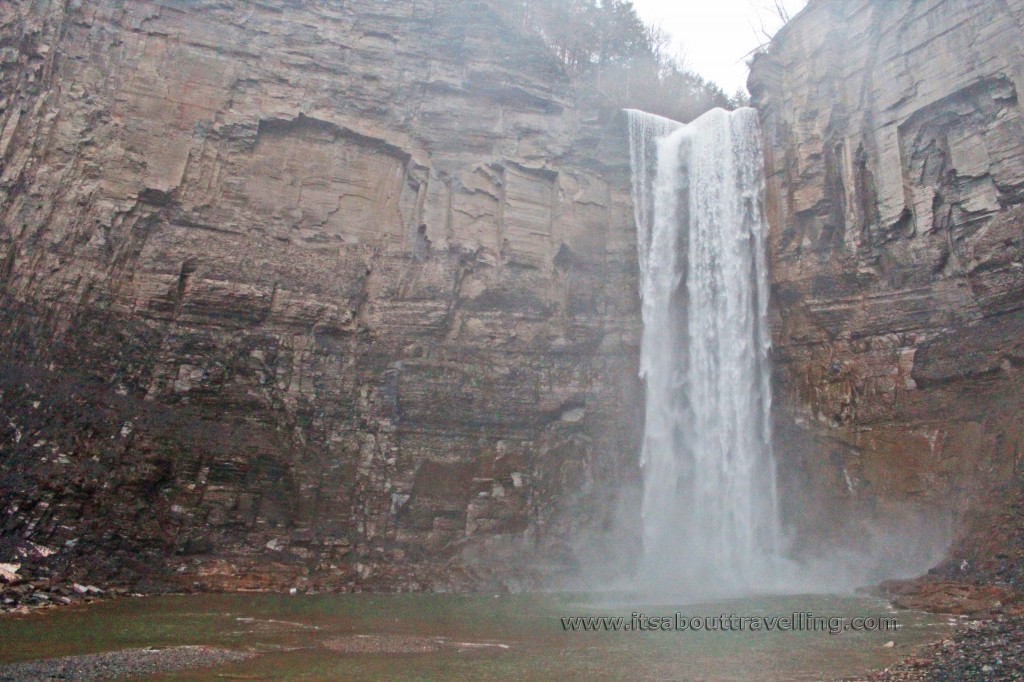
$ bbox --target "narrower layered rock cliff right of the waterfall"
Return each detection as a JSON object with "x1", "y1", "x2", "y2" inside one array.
[{"x1": 751, "y1": 0, "x2": 1024, "y2": 580}]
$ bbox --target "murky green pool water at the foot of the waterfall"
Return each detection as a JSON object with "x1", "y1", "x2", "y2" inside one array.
[{"x1": 0, "y1": 594, "x2": 949, "y2": 682}]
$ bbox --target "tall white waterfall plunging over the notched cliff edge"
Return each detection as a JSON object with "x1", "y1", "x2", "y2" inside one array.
[{"x1": 629, "y1": 109, "x2": 780, "y2": 595}]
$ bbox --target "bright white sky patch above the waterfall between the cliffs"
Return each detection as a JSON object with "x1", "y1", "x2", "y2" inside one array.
[{"x1": 633, "y1": 0, "x2": 807, "y2": 95}]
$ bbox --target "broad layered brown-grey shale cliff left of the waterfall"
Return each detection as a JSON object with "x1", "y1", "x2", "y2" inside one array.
[{"x1": 0, "y1": 0, "x2": 638, "y2": 589}]
